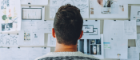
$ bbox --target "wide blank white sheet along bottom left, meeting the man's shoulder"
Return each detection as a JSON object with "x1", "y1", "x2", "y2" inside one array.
[{"x1": 0, "y1": 48, "x2": 50, "y2": 60}]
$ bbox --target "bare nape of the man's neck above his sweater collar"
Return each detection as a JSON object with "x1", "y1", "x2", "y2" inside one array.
[{"x1": 55, "y1": 43, "x2": 77, "y2": 52}]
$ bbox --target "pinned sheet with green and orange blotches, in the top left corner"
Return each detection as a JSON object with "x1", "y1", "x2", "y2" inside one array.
[{"x1": 0, "y1": 0, "x2": 21, "y2": 32}]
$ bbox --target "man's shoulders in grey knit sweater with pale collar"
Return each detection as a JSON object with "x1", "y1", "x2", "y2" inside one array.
[{"x1": 36, "y1": 52, "x2": 99, "y2": 60}]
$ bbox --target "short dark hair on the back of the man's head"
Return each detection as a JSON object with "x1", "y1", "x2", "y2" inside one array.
[{"x1": 54, "y1": 4, "x2": 83, "y2": 45}]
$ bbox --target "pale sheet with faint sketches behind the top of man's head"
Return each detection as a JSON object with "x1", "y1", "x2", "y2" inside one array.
[{"x1": 50, "y1": 0, "x2": 89, "y2": 18}]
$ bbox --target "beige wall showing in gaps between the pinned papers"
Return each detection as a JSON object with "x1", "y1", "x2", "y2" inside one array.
[{"x1": 22, "y1": 0, "x2": 140, "y2": 60}]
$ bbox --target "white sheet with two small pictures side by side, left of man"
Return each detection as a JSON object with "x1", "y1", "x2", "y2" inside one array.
[{"x1": 19, "y1": 31, "x2": 44, "y2": 46}]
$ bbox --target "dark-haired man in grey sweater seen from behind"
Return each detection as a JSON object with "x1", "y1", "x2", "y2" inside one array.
[{"x1": 36, "y1": 4, "x2": 99, "y2": 60}]
